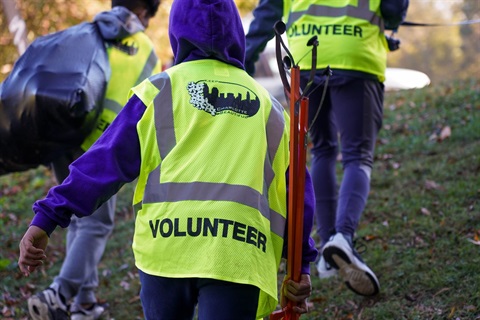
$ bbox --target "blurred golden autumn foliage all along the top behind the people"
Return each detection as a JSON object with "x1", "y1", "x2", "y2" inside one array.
[{"x1": 0, "y1": 0, "x2": 480, "y2": 83}]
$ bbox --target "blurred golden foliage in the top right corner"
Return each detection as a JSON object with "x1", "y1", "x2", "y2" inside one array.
[{"x1": 388, "y1": 0, "x2": 480, "y2": 83}]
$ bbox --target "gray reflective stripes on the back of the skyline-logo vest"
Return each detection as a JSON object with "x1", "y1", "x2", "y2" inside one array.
[{"x1": 142, "y1": 73, "x2": 286, "y2": 237}]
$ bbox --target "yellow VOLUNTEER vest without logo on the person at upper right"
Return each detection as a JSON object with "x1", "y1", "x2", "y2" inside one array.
[{"x1": 284, "y1": 0, "x2": 388, "y2": 82}]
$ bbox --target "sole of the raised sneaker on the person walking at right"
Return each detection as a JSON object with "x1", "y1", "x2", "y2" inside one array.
[{"x1": 323, "y1": 246, "x2": 380, "y2": 296}]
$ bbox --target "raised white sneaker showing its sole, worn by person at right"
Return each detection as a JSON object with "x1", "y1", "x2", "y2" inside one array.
[{"x1": 323, "y1": 233, "x2": 380, "y2": 296}]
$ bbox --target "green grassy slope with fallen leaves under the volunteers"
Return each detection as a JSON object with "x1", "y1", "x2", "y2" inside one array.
[{"x1": 0, "y1": 79, "x2": 480, "y2": 320}]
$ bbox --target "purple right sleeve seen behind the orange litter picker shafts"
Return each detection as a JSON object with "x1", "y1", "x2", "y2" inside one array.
[{"x1": 283, "y1": 169, "x2": 318, "y2": 274}]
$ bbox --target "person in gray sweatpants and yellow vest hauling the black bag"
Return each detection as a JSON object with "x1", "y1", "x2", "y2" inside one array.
[{"x1": 28, "y1": 0, "x2": 161, "y2": 320}]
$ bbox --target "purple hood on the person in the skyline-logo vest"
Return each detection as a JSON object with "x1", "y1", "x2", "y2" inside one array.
[{"x1": 169, "y1": 0, "x2": 245, "y2": 69}]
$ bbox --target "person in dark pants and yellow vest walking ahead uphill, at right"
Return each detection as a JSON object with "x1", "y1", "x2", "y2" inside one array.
[{"x1": 246, "y1": 0, "x2": 408, "y2": 296}]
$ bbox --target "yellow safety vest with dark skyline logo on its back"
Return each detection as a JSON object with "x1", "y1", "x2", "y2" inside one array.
[{"x1": 132, "y1": 60, "x2": 289, "y2": 317}]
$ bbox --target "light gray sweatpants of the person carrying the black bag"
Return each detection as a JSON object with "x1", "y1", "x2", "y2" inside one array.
[{"x1": 52, "y1": 153, "x2": 117, "y2": 304}]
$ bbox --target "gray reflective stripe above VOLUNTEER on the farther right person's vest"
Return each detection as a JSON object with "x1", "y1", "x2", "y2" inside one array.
[{"x1": 287, "y1": 0, "x2": 383, "y2": 30}]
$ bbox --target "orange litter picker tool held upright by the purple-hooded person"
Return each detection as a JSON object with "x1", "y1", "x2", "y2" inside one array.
[{"x1": 270, "y1": 21, "x2": 318, "y2": 320}]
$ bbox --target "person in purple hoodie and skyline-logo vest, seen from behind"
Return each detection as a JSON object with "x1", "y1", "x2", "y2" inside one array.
[{"x1": 18, "y1": 0, "x2": 318, "y2": 319}]
